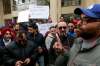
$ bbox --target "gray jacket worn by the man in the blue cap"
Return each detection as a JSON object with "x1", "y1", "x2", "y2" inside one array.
[{"x1": 68, "y1": 38, "x2": 100, "y2": 66}]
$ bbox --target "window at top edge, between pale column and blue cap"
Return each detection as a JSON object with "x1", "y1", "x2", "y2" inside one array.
[{"x1": 61, "y1": 0, "x2": 81, "y2": 6}]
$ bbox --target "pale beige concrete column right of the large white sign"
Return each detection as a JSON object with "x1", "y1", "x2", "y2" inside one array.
[{"x1": 50, "y1": 0, "x2": 59, "y2": 22}]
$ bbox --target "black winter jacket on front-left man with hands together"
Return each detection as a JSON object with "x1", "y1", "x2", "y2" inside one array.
[{"x1": 3, "y1": 40, "x2": 37, "y2": 66}]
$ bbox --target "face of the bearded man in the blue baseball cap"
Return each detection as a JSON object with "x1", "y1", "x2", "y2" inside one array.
[{"x1": 80, "y1": 15, "x2": 100, "y2": 40}]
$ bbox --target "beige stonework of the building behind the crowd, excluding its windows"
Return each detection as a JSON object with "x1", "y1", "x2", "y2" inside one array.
[{"x1": 0, "y1": 0, "x2": 100, "y2": 23}]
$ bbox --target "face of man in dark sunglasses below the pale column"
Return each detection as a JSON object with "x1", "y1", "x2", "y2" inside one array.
[{"x1": 57, "y1": 22, "x2": 67, "y2": 36}]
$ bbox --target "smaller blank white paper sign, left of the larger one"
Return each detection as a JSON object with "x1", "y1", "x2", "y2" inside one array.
[{"x1": 17, "y1": 10, "x2": 29, "y2": 23}]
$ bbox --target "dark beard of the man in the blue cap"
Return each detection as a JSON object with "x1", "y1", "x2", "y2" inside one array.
[{"x1": 80, "y1": 31, "x2": 96, "y2": 40}]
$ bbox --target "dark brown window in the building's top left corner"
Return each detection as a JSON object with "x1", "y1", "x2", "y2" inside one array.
[{"x1": 2, "y1": 0, "x2": 11, "y2": 14}]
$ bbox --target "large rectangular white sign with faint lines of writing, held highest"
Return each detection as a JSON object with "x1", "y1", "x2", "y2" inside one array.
[{"x1": 29, "y1": 5, "x2": 49, "y2": 19}]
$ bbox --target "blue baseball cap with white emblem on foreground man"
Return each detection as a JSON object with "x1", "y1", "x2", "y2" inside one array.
[{"x1": 74, "y1": 4, "x2": 100, "y2": 19}]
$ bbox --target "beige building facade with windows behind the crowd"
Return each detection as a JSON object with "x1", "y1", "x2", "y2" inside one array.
[{"x1": 0, "y1": 0, "x2": 100, "y2": 25}]
